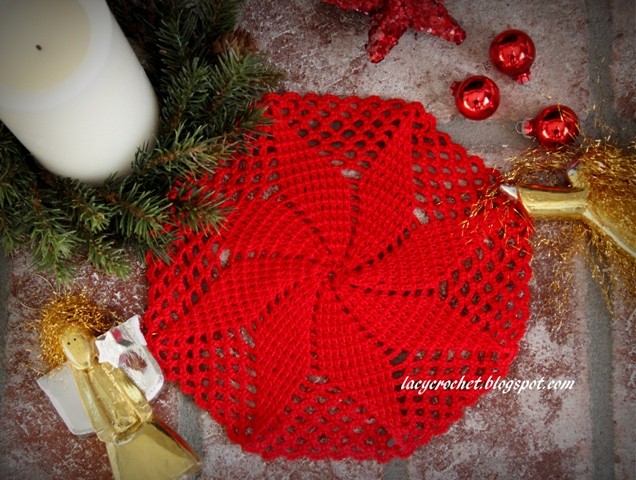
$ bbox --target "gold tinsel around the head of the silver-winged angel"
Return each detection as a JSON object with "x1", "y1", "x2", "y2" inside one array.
[{"x1": 36, "y1": 291, "x2": 117, "y2": 370}]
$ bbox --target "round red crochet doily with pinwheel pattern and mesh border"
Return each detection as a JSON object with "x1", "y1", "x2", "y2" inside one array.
[{"x1": 144, "y1": 93, "x2": 531, "y2": 462}]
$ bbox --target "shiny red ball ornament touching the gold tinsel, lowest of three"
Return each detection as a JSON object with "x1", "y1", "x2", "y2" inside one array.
[{"x1": 522, "y1": 105, "x2": 580, "y2": 149}]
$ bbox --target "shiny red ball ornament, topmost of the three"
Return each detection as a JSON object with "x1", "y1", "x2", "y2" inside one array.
[{"x1": 490, "y1": 30, "x2": 536, "y2": 84}]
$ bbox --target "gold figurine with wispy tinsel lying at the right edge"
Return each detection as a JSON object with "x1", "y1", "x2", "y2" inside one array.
[{"x1": 484, "y1": 138, "x2": 636, "y2": 329}]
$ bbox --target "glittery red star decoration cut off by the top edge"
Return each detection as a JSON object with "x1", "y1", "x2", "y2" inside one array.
[{"x1": 324, "y1": 0, "x2": 466, "y2": 63}]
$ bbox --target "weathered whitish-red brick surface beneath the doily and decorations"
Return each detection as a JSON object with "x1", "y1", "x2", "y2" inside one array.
[{"x1": 0, "y1": 0, "x2": 636, "y2": 480}]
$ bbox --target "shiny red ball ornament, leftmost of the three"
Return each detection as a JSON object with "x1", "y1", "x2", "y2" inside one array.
[{"x1": 451, "y1": 75, "x2": 499, "y2": 120}]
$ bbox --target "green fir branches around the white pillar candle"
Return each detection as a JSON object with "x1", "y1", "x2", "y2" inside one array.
[{"x1": 0, "y1": 0, "x2": 282, "y2": 281}]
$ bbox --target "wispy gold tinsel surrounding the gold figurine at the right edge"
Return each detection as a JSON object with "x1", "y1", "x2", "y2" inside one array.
[{"x1": 492, "y1": 140, "x2": 636, "y2": 327}]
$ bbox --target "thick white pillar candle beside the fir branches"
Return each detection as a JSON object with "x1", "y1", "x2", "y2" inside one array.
[{"x1": 0, "y1": 0, "x2": 159, "y2": 184}]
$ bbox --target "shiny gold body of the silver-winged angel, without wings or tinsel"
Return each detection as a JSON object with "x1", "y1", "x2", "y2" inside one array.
[{"x1": 60, "y1": 326, "x2": 201, "y2": 480}]
